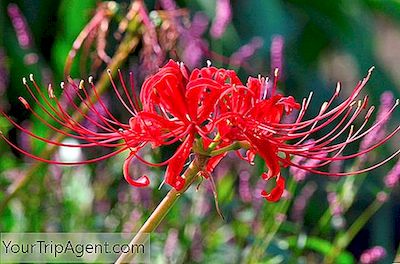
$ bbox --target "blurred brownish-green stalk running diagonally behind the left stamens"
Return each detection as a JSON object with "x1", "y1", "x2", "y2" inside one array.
[{"x1": 0, "y1": 2, "x2": 140, "y2": 215}]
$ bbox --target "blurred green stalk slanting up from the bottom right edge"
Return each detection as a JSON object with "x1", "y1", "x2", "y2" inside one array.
[{"x1": 324, "y1": 194, "x2": 385, "y2": 264}]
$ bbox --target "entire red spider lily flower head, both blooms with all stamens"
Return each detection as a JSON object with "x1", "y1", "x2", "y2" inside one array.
[{"x1": 1, "y1": 61, "x2": 400, "y2": 201}]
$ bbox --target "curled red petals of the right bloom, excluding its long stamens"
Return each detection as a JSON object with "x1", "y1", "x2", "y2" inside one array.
[{"x1": 212, "y1": 69, "x2": 300, "y2": 201}]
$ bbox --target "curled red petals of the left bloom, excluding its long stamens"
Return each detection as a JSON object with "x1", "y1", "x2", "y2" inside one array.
[{"x1": 139, "y1": 60, "x2": 238, "y2": 190}]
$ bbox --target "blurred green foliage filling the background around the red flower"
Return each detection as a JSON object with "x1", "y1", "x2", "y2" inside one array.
[{"x1": 0, "y1": 0, "x2": 400, "y2": 263}]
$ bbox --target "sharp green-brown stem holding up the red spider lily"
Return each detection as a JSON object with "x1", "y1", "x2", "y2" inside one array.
[{"x1": 115, "y1": 155, "x2": 208, "y2": 264}]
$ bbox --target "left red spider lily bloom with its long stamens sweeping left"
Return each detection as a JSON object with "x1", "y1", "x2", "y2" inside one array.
[{"x1": 1, "y1": 61, "x2": 228, "y2": 190}]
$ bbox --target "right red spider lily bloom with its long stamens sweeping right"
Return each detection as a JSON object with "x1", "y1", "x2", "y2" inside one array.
[{"x1": 212, "y1": 69, "x2": 400, "y2": 201}]
